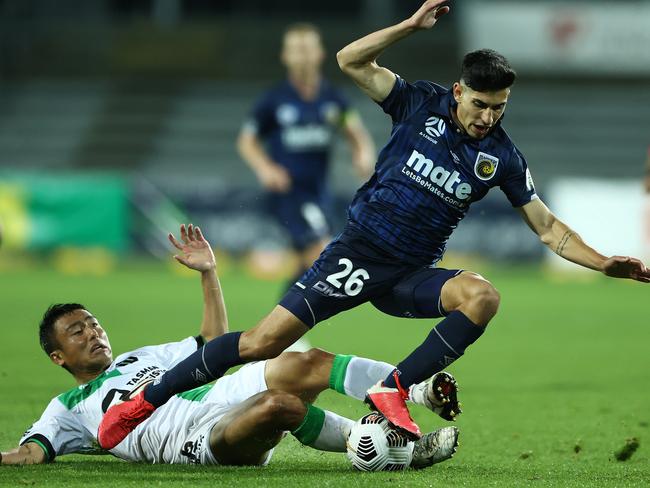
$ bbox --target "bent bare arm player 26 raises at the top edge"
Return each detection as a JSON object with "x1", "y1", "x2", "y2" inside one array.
[{"x1": 336, "y1": 0, "x2": 449, "y2": 102}]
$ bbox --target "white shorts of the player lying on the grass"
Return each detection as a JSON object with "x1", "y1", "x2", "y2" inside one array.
[{"x1": 120, "y1": 361, "x2": 273, "y2": 465}]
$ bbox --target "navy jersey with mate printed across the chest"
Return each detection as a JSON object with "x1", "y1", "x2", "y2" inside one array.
[{"x1": 348, "y1": 76, "x2": 537, "y2": 264}]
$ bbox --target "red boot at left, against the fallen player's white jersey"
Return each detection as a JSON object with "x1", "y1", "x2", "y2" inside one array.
[{"x1": 97, "y1": 391, "x2": 156, "y2": 450}]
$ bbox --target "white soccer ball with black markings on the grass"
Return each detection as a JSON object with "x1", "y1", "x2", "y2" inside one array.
[{"x1": 347, "y1": 412, "x2": 414, "y2": 471}]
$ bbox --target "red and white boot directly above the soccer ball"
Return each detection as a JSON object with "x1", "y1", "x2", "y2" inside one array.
[{"x1": 366, "y1": 373, "x2": 422, "y2": 441}]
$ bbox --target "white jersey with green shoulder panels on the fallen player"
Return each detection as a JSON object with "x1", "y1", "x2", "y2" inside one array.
[{"x1": 20, "y1": 337, "x2": 202, "y2": 461}]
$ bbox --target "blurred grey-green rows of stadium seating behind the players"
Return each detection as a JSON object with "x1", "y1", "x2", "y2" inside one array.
[{"x1": 0, "y1": 80, "x2": 650, "y2": 185}]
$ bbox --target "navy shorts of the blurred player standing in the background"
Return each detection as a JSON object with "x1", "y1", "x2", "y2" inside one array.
[{"x1": 269, "y1": 192, "x2": 331, "y2": 251}]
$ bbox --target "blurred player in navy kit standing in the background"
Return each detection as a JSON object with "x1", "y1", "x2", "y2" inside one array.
[{"x1": 237, "y1": 23, "x2": 375, "y2": 285}]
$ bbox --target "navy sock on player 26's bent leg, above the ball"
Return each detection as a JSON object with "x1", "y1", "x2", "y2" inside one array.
[{"x1": 384, "y1": 311, "x2": 485, "y2": 389}]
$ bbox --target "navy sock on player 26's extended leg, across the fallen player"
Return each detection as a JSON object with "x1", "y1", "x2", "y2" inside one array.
[{"x1": 144, "y1": 332, "x2": 243, "y2": 408}]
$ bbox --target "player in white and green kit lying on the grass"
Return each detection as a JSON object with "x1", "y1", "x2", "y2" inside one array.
[{"x1": 1, "y1": 227, "x2": 458, "y2": 467}]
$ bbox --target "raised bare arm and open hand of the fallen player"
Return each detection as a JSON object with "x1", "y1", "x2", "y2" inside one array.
[{"x1": 168, "y1": 224, "x2": 228, "y2": 341}]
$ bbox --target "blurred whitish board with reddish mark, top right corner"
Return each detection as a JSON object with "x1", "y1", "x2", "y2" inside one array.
[{"x1": 461, "y1": 1, "x2": 650, "y2": 75}]
